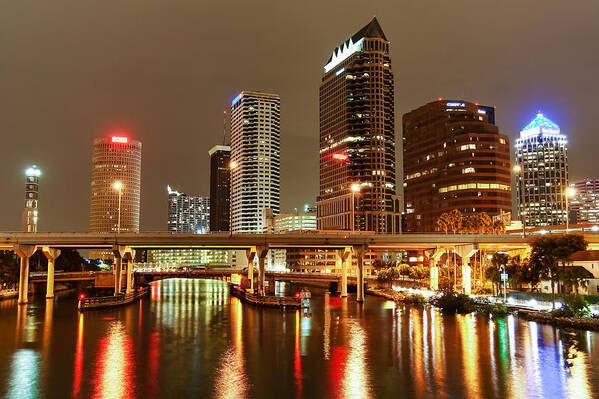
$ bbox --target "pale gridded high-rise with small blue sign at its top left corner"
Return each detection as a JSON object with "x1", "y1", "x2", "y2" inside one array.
[{"x1": 230, "y1": 90, "x2": 281, "y2": 233}]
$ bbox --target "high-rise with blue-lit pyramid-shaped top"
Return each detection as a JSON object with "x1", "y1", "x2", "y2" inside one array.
[{"x1": 516, "y1": 112, "x2": 568, "y2": 226}]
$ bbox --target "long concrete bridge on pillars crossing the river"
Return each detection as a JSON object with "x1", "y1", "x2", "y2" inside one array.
[{"x1": 0, "y1": 232, "x2": 599, "y2": 303}]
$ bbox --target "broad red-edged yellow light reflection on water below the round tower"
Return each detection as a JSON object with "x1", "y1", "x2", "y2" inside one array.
[{"x1": 94, "y1": 321, "x2": 135, "y2": 399}]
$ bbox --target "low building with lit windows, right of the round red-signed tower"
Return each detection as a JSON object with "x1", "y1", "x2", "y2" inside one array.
[{"x1": 166, "y1": 186, "x2": 210, "y2": 234}]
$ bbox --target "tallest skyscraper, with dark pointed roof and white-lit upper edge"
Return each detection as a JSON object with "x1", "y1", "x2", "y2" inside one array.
[{"x1": 317, "y1": 18, "x2": 401, "y2": 233}]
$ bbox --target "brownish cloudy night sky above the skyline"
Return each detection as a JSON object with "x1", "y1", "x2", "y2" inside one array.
[{"x1": 0, "y1": 0, "x2": 599, "y2": 231}]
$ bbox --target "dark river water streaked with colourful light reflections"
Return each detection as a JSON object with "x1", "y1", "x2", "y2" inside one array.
[{"x1": 0, "y1": 279, "x2": 599, "y2": 399}]
